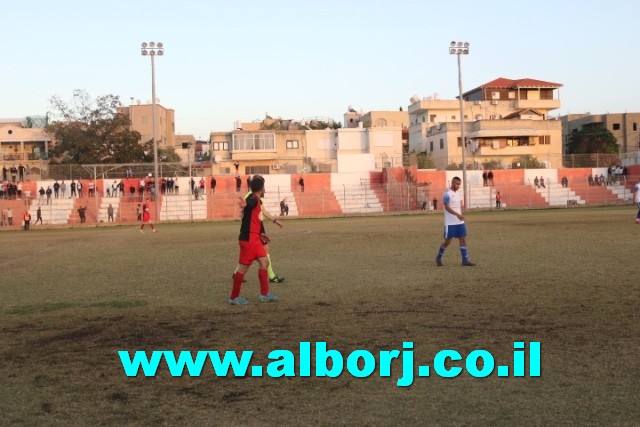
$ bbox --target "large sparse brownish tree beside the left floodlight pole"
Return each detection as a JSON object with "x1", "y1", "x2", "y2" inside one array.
[{"x1": 45, "y1": 89, "x2": 153, "y2": 164}]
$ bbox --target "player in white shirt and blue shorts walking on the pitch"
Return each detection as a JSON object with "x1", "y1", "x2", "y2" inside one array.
[{"x1": 436, "y1": 176, "x2": 475, "y2": 267}]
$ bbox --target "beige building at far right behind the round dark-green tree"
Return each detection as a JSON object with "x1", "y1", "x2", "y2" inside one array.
[{"x1": 560, "y1": 113, "x2": 640, "y2": 154}]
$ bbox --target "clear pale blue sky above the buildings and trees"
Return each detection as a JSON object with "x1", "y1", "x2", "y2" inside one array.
[{"x1": 0, "y1": 0, "x2": 640, "y2": 138}]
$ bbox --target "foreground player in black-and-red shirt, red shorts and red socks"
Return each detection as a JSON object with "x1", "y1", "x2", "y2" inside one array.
[{"x1": 229, "y1": 175, "x2": 279, "y2": 305}]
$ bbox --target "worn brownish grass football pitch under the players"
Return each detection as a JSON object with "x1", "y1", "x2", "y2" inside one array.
[{"x1": 0, "y1": 206, "x2": 640, "y2": 426}]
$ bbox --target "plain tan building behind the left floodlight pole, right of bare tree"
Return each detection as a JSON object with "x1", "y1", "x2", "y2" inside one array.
[{"x1": 118, "y1": 104, "x2": 175, "y2": 149}]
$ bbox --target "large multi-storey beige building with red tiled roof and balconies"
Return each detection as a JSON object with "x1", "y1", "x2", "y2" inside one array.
[{"x1": 408, "y1": 78, "x2": 563, "y2": 169}]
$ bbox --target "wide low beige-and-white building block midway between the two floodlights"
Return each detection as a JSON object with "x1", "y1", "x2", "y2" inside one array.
[{"x1": 210, "y1": 112, "x2": 408, "y2": 174}]
